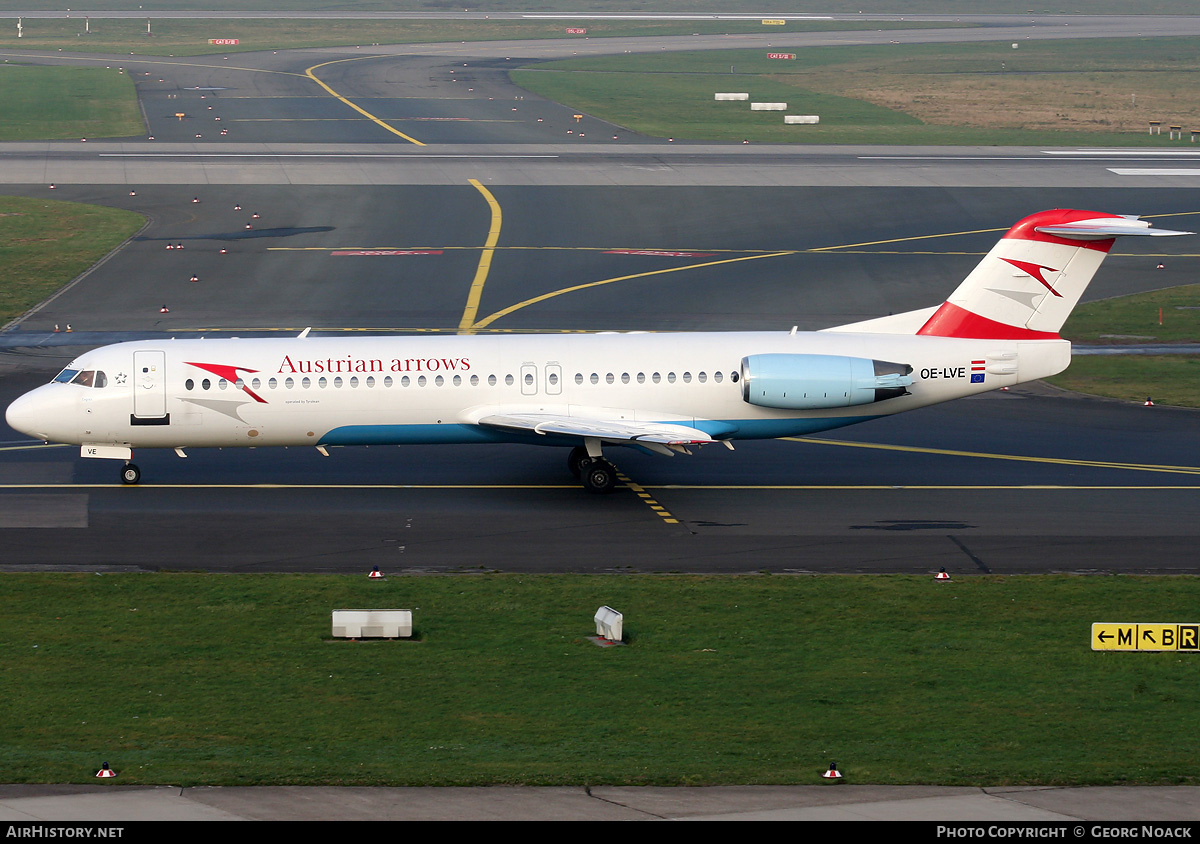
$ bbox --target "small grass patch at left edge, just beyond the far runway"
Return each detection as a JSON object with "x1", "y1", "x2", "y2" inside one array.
[{"x1": 0, "y1": 64, "x2": 145, "y2": 140}]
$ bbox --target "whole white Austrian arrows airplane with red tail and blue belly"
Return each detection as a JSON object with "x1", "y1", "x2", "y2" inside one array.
[{"x1": 6, "y1": 210, "x2": 1192, "y2": 492}]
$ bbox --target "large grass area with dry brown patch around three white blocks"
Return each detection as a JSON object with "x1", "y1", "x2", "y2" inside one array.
[{"x1": 511, "y1": 36, "x2": 1200, "y2": 148}]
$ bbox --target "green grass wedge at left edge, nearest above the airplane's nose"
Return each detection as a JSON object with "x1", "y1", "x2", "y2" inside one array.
[{"x1": 0, "y1": 197, "x2": 145, "y2": 324}]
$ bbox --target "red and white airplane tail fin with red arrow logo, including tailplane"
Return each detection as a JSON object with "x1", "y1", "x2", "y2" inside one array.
[{"x1": 917, "y1": 209, "x2": 1189, "y2": 340}]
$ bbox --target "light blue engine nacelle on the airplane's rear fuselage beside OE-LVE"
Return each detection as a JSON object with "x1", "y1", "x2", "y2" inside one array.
[{"x1": 742, "y1": 354, "x2": 912, "y2": 411}]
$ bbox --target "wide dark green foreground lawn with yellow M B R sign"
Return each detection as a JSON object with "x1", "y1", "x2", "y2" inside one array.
[{"x1": 0, "y1": 574, "x2": 1200, "y2": 785}]
